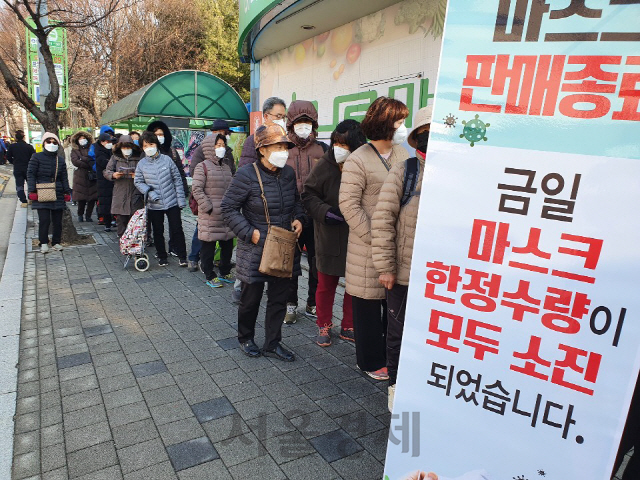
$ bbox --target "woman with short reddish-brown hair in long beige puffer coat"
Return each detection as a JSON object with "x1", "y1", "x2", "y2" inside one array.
[{"x1": 340, "y1": 97, "x2": 409, "y2": 380}]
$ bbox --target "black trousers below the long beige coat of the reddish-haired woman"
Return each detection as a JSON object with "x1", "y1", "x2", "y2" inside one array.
[{"x1": 352, "y1": 297, "x2": 387, "y2": 372}]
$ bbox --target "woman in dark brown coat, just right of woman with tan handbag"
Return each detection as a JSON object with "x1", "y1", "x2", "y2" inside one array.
[{"x1": 71, "y1": 131, "x2": 98, "y2": 222}]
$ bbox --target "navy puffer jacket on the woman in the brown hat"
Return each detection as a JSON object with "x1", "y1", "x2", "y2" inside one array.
[{"x1": 221, "y1": 162, "x2": 305, "y2": 283}]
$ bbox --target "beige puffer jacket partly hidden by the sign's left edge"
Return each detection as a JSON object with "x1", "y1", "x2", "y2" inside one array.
[{"x1": 371, "y1": 156, "x2": 424, "y2": 285}]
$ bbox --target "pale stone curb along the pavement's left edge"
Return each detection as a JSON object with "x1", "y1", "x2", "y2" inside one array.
[{"x1": 0, "y1": 201, "x2": 28, "y2": 478}]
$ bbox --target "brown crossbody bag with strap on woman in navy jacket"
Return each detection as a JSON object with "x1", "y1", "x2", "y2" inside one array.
[{"x1": 253, "y1": 163, "x2": 298, "y2": 278}]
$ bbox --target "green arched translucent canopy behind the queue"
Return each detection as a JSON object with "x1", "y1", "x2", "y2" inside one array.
[{"x1": 100, "y1": 70, "x2": 249, "y2": 128}]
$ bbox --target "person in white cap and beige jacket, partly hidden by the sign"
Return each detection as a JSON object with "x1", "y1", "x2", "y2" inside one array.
[{"x1": 371, "y1": 106, "x2": 433, "y2": 411}]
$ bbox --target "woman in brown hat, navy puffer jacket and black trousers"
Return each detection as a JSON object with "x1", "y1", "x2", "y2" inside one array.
[{"x1": 221, "y1": 125, "x2": 305, "y2": 362}]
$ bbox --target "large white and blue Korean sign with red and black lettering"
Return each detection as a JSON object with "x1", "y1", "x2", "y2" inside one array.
[{"x1": 385, "y1": 0, "x2": 640, "y2": 480}]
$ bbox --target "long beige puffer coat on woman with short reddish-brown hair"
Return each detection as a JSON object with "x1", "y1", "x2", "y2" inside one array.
[{"x1": 340, "y1": 144, "x2": 409, "y2": 300}]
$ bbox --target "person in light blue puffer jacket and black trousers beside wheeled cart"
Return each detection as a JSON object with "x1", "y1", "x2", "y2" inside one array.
[{"x1": 134, "y1": 131, "x2": 187, "y2": 267}]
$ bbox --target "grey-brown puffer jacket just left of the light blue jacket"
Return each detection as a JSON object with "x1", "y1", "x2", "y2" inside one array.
[{"x1": 104, "y1": 144, "x2": 144, "y2": 215}]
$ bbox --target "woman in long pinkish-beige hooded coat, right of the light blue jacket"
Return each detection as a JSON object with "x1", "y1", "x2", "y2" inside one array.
[{"x1": 191, "y1": 135, "x2": 235, "y2": 288}]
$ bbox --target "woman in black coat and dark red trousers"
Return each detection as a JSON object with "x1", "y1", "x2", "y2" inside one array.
[{"x1": 302, "y1": 120, "x2": 366, "y2": 347}]
